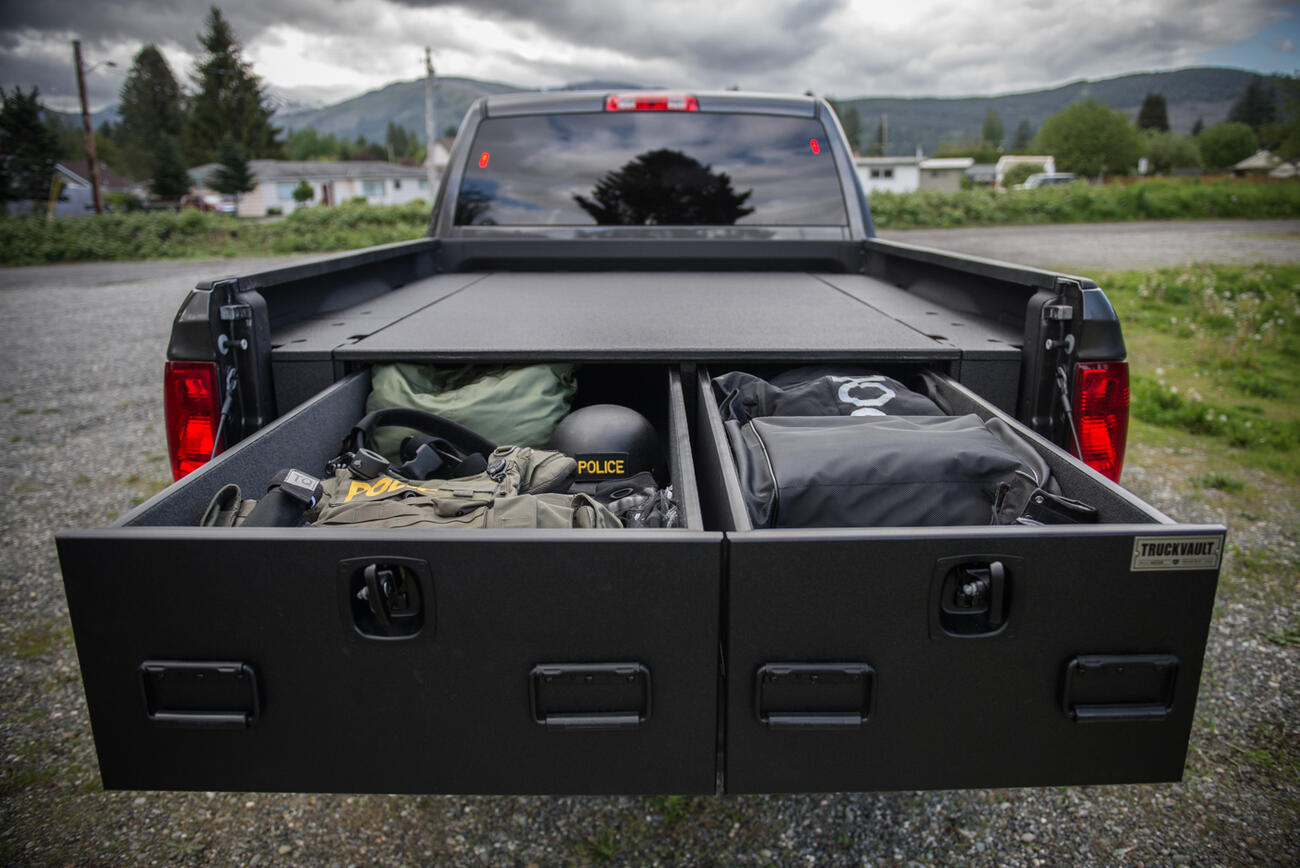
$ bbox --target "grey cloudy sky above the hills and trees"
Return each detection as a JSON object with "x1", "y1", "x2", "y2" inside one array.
[{"x1": 0, "y1": 0, "x2": 1300, "y2": 109}]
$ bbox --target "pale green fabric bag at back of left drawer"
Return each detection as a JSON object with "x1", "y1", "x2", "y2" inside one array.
[{"x1": 365, "y1": 361, "x2": 577, "y2": 460}]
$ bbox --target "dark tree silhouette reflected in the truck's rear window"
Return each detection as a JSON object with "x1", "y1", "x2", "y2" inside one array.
[{"x1": 573, "y1": 148, "x2": 754, "y2": 226}]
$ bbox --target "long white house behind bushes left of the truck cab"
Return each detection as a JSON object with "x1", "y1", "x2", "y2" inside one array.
[{"x1": 190, "y1": 160, "x2": 433, "y2": 217}]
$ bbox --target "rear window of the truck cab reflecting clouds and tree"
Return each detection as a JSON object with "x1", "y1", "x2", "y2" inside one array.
[{"x1": 455, "y1": 112, "x2": 848, "y2": 226}]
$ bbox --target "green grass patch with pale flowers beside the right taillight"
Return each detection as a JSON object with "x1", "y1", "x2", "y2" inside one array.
[{"x1": 1096, "y1": 265, "x2": 1300, "y2": 480}]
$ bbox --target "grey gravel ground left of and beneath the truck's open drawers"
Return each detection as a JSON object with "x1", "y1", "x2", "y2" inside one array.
[{"x1": 0, "y1": 232, "x2": 1300, "y2": 865}]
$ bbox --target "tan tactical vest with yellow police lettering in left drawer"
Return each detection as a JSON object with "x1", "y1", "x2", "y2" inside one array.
[{"x1": 307, "y1": 446, "x2": 621, "y2": 529}]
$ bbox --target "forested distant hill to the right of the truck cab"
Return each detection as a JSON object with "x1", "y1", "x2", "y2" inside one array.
[{"x1": 839, "y1": 68, "x2": 1279, "y2": 155}]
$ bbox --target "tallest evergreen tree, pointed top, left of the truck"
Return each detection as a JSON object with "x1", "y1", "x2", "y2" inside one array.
[{"x1": 185, "y1": 6, "x2": 281, "y2": 165}]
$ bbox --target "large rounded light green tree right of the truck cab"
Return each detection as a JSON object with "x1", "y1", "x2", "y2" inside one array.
[{"x1": 1034, "y1": 100, "x2": 1140, "y2": 175}]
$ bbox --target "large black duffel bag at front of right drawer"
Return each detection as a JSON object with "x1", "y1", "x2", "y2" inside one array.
[{"x1": 725, "y1": 416, "x2": 1045, "y2": 528}]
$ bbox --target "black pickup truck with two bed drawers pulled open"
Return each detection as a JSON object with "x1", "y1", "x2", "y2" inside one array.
[{"x1": 57, "y1": 92, "x2": 1225, "y2": 794}]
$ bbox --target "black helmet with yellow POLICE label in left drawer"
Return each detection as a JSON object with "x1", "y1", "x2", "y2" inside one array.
[{"x1": 551, "y1": 404, "x2": 660, "y2": 482}]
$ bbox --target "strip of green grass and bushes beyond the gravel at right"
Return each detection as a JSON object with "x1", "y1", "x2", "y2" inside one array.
[{"x1": 870, "y1": 179, "x2": 1300, "y2": 229}]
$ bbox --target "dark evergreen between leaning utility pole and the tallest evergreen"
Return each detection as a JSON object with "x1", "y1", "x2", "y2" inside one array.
[{"x1": 113, "y1": 45, "x2": 185, "y2": 178}]
